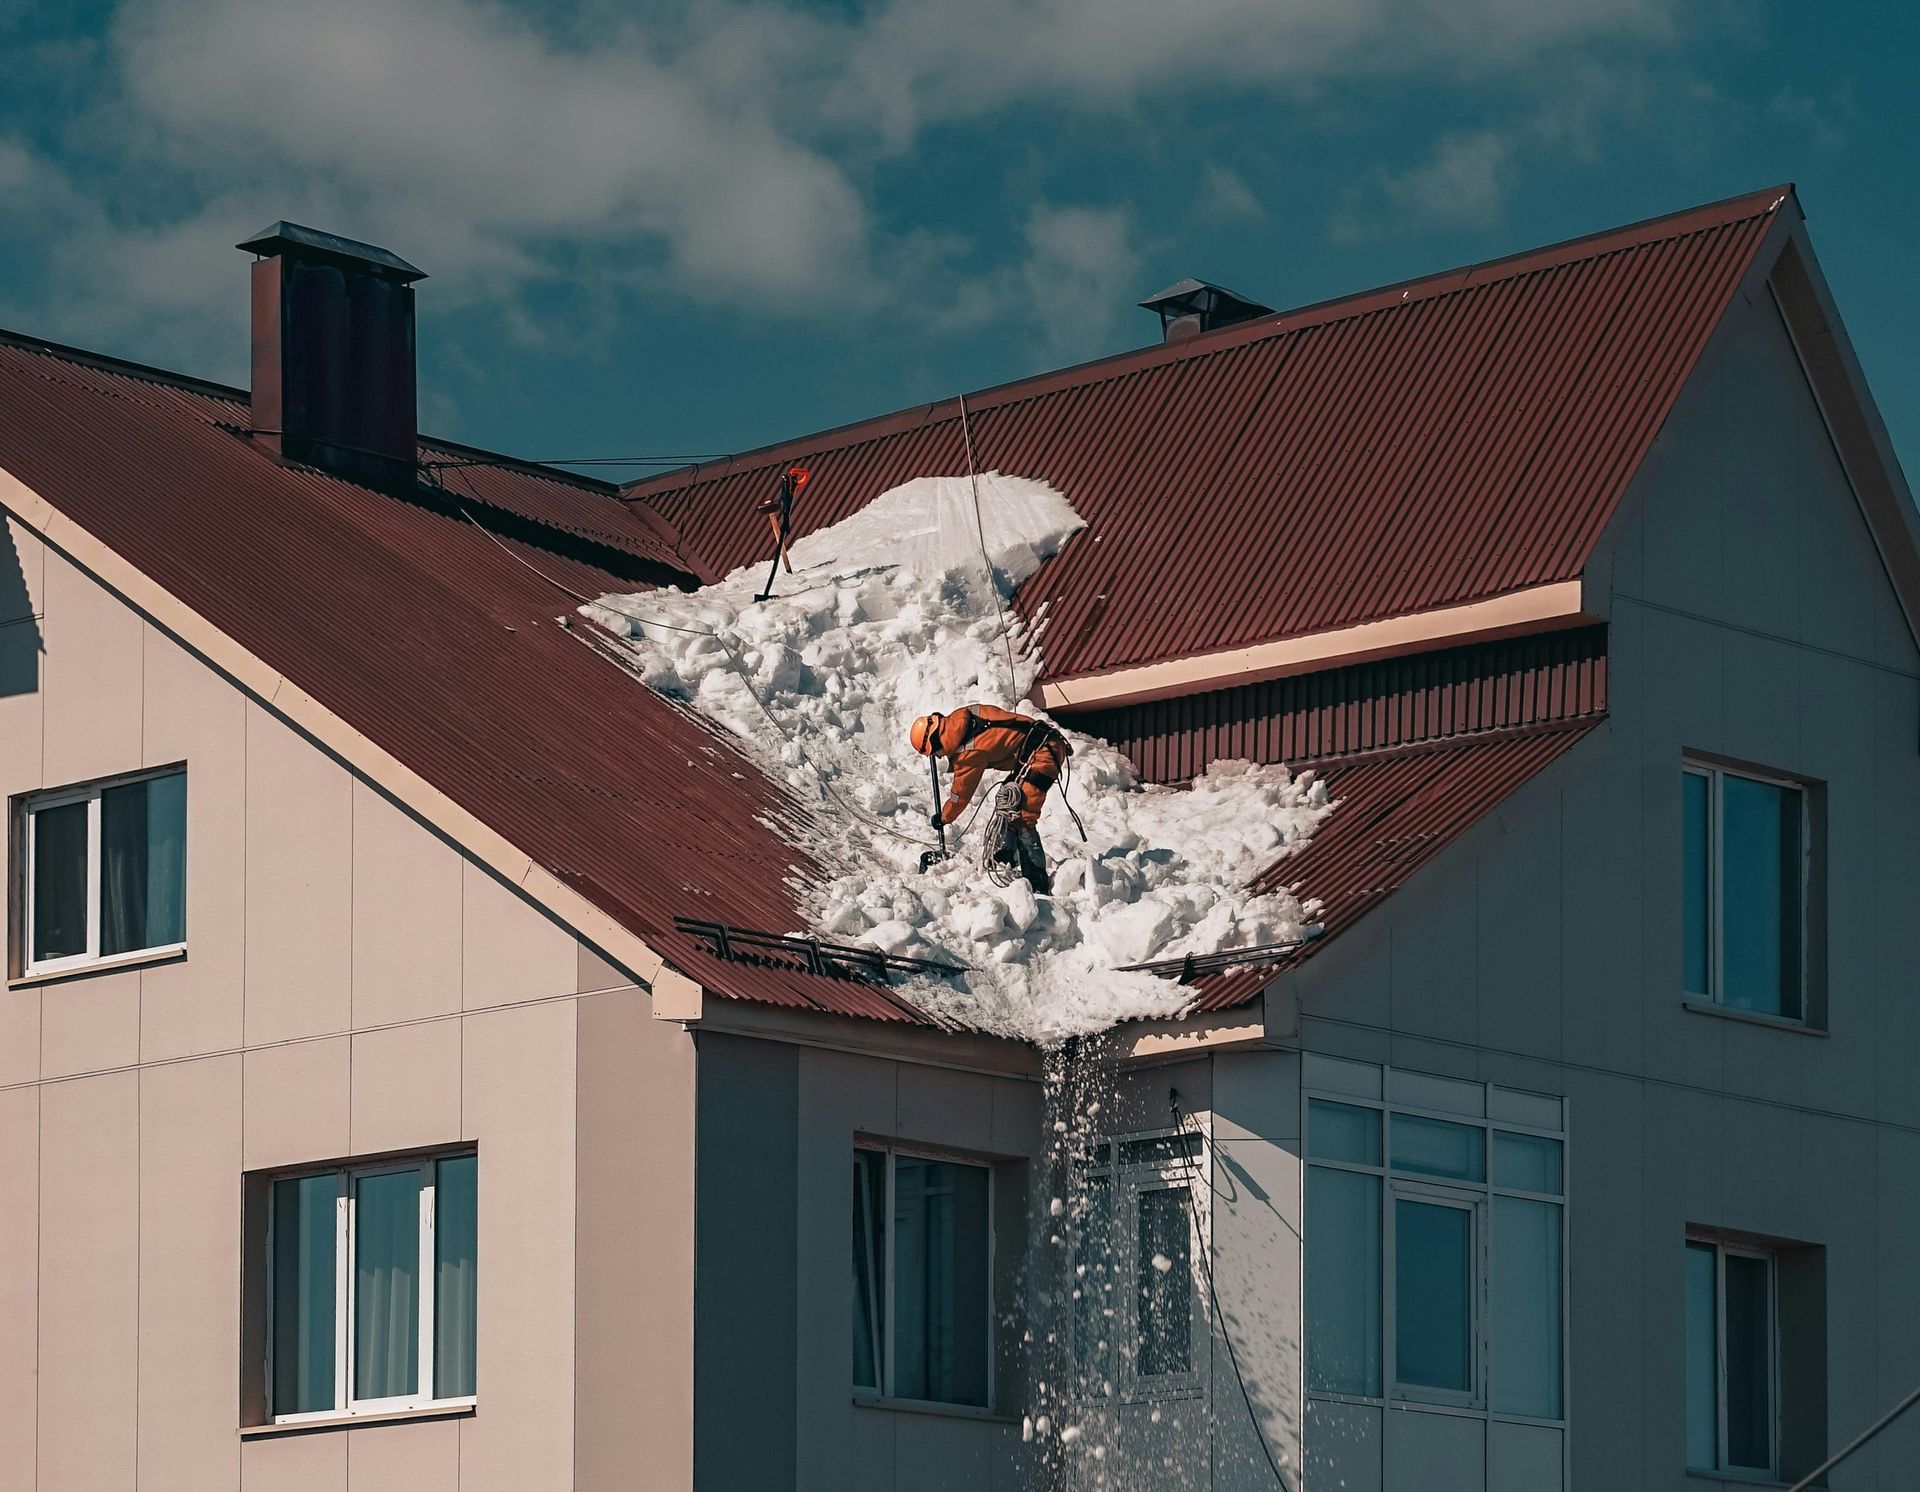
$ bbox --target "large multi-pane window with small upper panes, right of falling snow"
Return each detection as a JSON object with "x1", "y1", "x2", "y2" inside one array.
[{"x1": 1306, "y1": 1095, "x2": 1565, "y2": 1421}]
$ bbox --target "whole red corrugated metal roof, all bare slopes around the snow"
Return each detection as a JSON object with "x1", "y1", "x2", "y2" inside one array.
[{"x1": 0, "y1": 192, "x2": 1780, "y2": 1022}]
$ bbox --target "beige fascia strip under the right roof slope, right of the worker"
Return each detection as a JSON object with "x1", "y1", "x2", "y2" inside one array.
[{"x1": 1039, "y1": 578, "x2": 1601, "y2": 710}]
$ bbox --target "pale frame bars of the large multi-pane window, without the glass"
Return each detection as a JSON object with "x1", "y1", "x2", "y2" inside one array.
[{"x1": 1300, "y1": 1089, "x2": 1572, "y2": 1427}]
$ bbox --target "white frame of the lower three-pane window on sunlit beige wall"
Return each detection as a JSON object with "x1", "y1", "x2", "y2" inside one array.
[{"x1": 265, "y1": 1150, "x2": 478, "y2": 1425}]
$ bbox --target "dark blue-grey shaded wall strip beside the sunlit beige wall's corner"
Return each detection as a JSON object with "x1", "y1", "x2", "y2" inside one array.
[{"x1": 693, "y1": 1035, "x2": 799, "y2": 1492}]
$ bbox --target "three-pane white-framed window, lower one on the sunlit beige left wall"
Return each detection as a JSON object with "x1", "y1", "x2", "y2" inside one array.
[{"x1": 267, "y1": 1154, "x2": 478, "y2": 1421}]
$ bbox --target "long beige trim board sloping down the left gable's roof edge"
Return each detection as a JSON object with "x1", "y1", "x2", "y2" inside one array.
[{"x1": 0, "y1": 467, "x2": 701, "y2": 1014}]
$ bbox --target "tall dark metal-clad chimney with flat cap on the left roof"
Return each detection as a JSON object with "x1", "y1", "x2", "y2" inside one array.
[{"x1": 236, "y1": 223, "x2": 426, "y2": 486}]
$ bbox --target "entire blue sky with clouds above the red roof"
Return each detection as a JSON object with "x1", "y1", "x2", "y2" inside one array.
[{"x1": 0, "y1": 0, "x2": 1920, "y2": 474}]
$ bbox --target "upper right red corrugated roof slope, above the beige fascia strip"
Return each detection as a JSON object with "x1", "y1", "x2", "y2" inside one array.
[{"x1": 628, "y1": 186, "x2": 1791, "y2": 678}]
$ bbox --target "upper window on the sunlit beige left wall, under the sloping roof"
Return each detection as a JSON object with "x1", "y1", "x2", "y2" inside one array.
[{"x1": 15, "y1": 766, "x2": 186, "y2": 974}]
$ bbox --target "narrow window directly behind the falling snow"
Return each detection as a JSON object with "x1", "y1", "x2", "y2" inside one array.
[{"x1": 1069, "y1": 1131, "x2": 1204, "y2": 1400}]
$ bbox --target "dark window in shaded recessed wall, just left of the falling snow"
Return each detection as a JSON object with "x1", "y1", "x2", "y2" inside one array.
[{"x1": 852, "y1": 1148, "x2": 993, "y2": 1408}]
